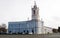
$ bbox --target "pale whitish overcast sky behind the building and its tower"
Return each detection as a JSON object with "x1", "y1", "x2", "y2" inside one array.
[{"x1": 0, "y1": 0, "x2": 60, "y2": 28}]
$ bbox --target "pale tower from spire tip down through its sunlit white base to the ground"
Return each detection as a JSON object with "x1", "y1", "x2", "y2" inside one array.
[{"x1": 32, "y1": 2, "x2": 43, "y2": 34}]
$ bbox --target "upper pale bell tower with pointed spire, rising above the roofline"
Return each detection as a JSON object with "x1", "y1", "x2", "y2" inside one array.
[{"x1": 32, "y1": 2, "x2": 39, "y2": 20}]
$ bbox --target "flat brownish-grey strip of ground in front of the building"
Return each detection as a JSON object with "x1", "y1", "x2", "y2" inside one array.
[{"x1": 0, "y1": 34, "x2": 60, "y2": 38}]
